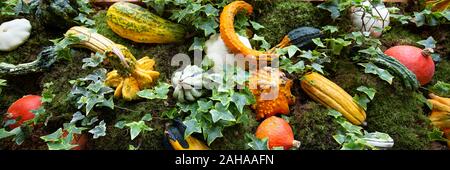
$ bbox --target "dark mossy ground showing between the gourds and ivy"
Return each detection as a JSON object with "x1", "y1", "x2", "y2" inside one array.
[{"x1": 0, "y1": 0, "x2": 450, "y2": 150}]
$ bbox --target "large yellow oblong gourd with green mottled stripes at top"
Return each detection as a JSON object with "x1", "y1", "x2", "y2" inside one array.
[{"x1": 106, "y1": 2, "x2": 186, "y2": 43}]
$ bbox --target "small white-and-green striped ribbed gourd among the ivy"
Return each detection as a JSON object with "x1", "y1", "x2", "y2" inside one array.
[{"x1": 172, "y1": 65, "x2": 204, "y2": 102}]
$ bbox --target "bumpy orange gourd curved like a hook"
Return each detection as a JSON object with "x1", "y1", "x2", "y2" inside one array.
[{"x1": 220, "y1": 1, "x2": 274, "y2": 61}]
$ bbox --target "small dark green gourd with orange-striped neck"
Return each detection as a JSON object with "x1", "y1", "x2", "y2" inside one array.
[{"x1": 271, "y1": 27, "x2": 322, "y2": 51}]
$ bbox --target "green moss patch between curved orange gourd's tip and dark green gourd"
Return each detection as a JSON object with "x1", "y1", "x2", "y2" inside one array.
[{"x1": 256, "y1": 0, "x2": 326, "y2": 46}]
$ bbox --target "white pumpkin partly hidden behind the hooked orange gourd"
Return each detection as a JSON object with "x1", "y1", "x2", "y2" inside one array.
[{"x1": 205, "y1": 34, "x2": 252, "y2": 73}]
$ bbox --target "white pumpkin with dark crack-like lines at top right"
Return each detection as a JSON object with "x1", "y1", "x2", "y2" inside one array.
[{"x1": 351, "y1": 1, "x2": 389, "y2": 37}]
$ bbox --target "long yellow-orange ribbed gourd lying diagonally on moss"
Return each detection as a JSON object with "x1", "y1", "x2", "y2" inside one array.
[{"x1": 301, "y1": 72, "x2": 366, "y2": 125}]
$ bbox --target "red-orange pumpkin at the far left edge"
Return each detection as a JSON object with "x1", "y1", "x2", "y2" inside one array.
[{"x1": 5, "y1": 95, "x2": 42, "y2": 129}]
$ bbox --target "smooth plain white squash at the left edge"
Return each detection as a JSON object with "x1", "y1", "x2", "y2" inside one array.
[{"x1": 0, "y1": 19, "x2": 31, "y2": 51}]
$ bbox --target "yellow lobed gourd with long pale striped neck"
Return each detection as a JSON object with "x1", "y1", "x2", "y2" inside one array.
[{"x1": 65, "y1": 26, "x2": 159, "y2": 100}]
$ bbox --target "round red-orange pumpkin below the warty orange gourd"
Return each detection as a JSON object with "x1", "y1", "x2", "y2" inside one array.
[{"x1": 255, "y1": 116, "x2": 300, "y2": 150}]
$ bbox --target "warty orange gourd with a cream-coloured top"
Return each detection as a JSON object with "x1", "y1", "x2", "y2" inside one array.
[{"x1": 248, "y1": 67, "x2": 295, "y2": 119}]
